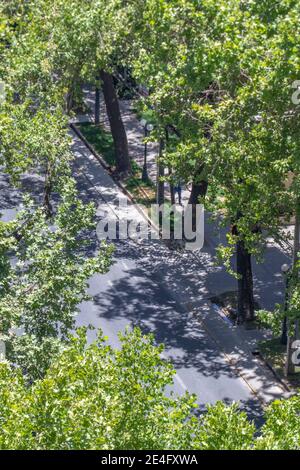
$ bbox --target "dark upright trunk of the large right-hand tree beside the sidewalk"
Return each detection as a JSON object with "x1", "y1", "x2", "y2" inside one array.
[{"x1": 236, "y1": 240, "x2": 254, "y2": 323}]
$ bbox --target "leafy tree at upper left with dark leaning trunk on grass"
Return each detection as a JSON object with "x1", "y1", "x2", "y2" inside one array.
[{"x1": 16, "y1": 0, "x2": 135, "y2": 173}]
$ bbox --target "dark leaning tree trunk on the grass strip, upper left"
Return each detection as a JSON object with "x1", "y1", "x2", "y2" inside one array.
[{"x1": 100, "y1": 70, "x2": 131, "y2": 173}]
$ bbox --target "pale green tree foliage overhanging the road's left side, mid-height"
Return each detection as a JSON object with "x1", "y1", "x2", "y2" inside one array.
[{"x1": 0, "y1": 179, "x2": 112, "y2": 379}]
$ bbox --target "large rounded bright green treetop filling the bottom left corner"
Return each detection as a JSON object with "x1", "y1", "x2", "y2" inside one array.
[{"x1": 0, "y1": 329, "x2": 199, "y2": 450}]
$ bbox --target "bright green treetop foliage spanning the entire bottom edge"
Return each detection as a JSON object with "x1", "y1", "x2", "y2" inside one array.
[{"x1": 0, "y1": 329, "x2": 300, "y2": 450}]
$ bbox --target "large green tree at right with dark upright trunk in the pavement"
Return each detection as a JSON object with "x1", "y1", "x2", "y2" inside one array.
[{"x1": 130, "y1": 0, "x2": 299, "y2": 321}]
